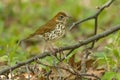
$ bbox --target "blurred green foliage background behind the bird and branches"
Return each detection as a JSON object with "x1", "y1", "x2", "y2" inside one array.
[{"x1": 0, "y1": 0, "x2": 120, "y2": 79}]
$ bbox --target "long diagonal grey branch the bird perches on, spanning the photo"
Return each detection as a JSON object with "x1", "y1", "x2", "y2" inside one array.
[{"x1": 0, "y1": 24, "x2": 120, "y2": 75}]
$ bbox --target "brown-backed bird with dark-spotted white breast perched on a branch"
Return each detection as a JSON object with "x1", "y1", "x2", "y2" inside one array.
[{"x1": 22, "y1": 12, "x2": 69, "y2": 52}]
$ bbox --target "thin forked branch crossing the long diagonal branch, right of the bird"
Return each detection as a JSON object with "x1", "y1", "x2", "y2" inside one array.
[{"x1": 70, "y1": 0, "x2": 115, "y2": 73}]
